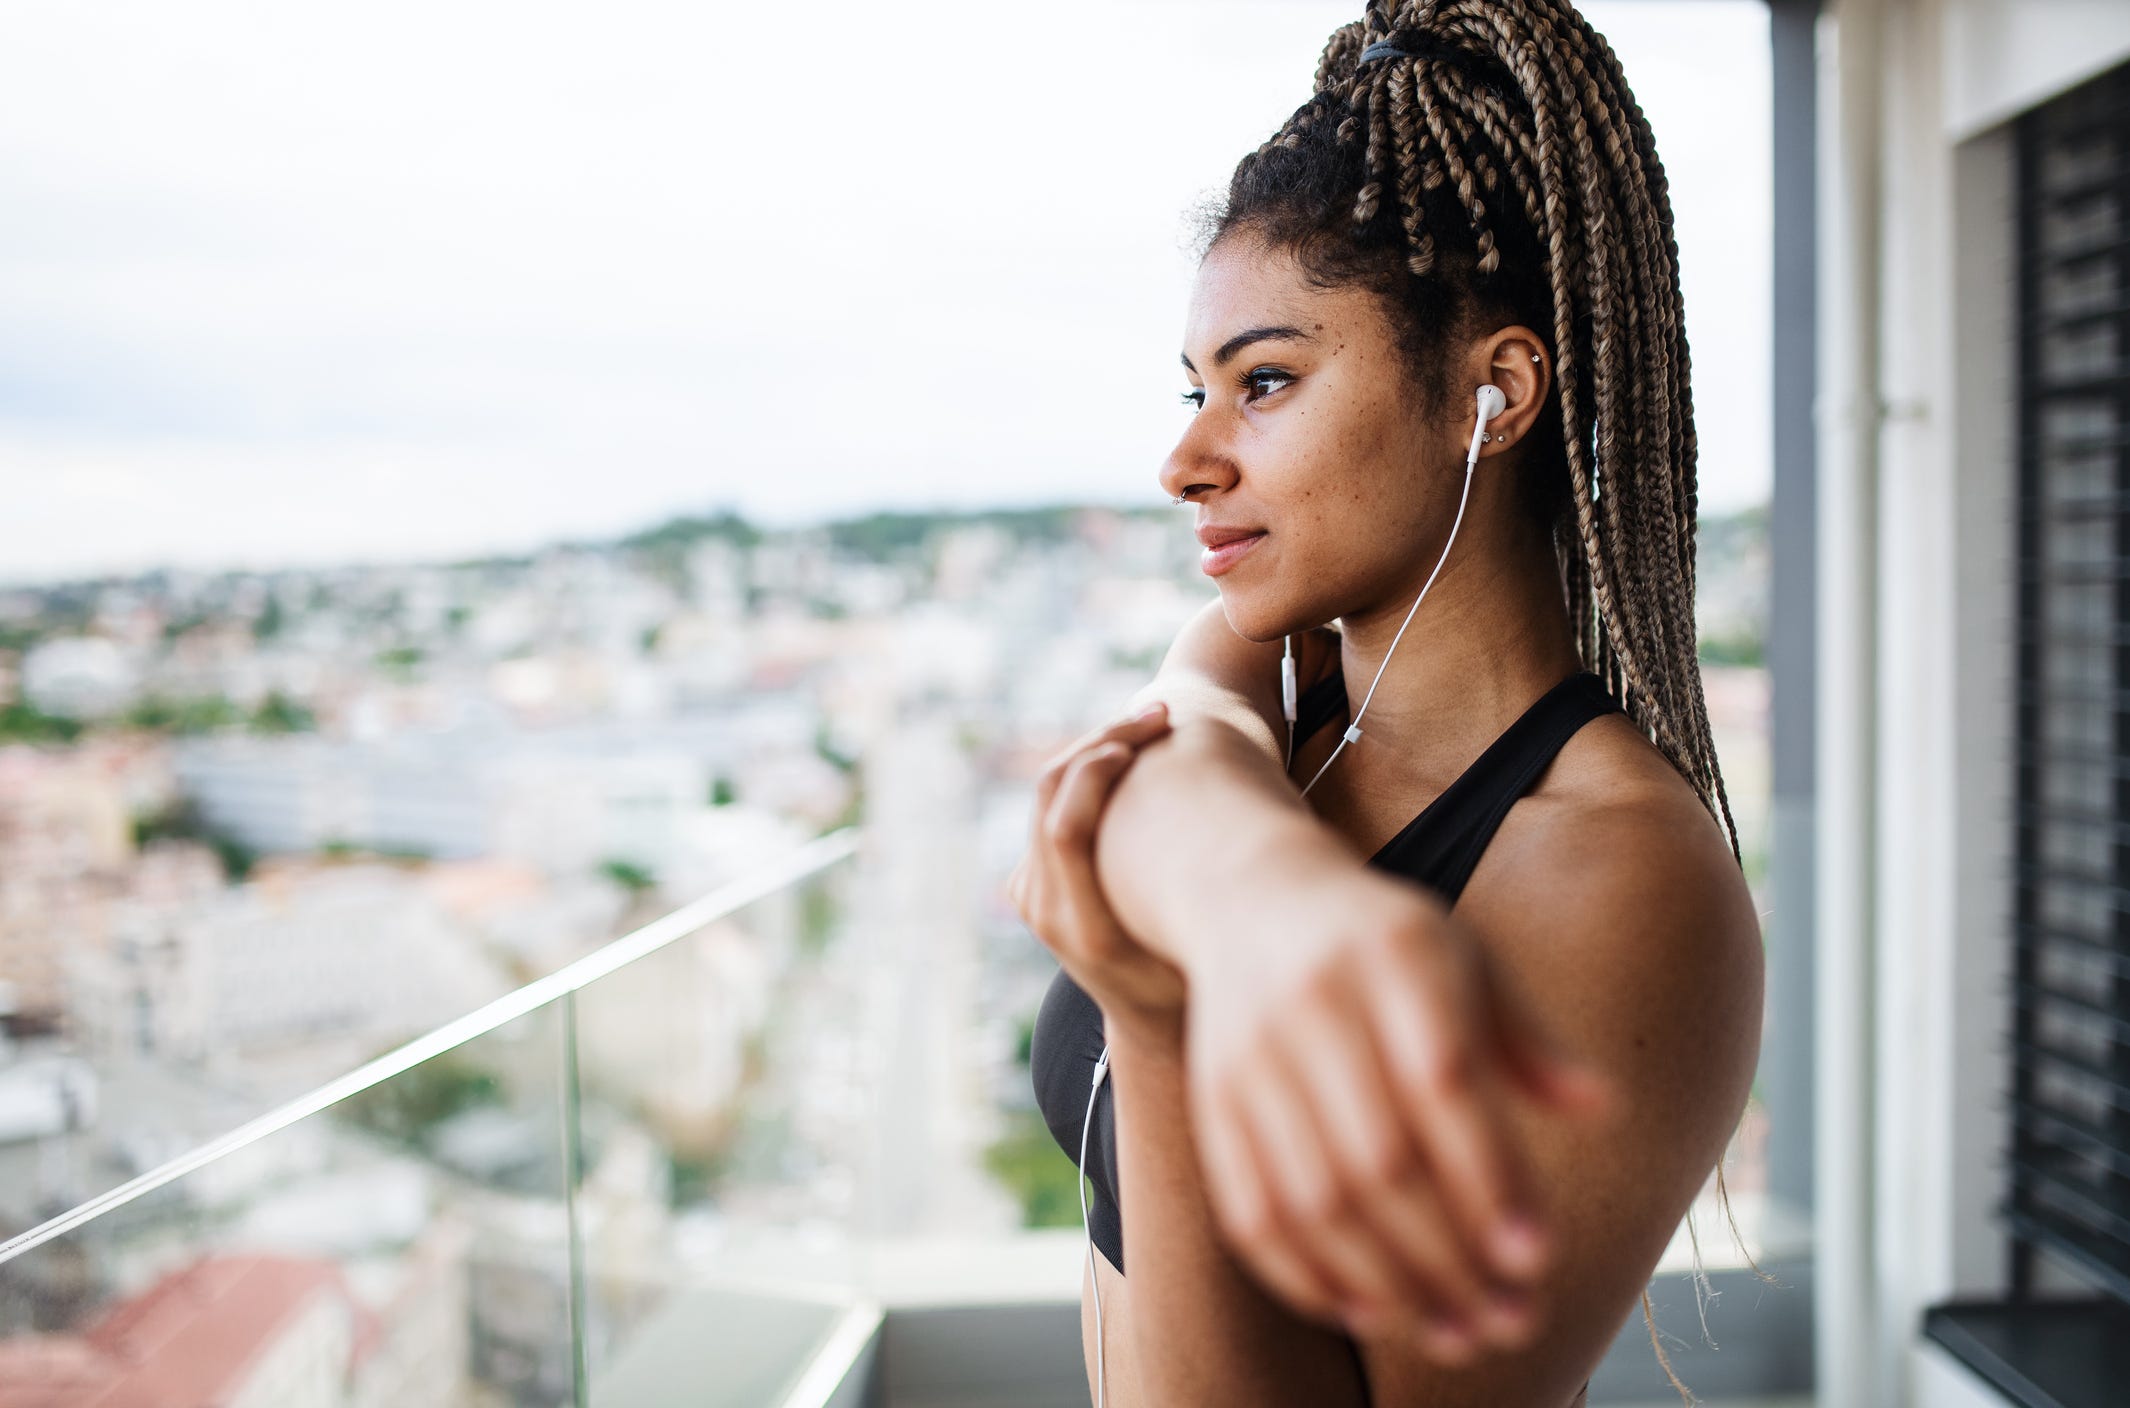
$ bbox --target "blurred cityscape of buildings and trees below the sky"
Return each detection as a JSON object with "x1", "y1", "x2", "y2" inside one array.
[{"x1": 0, "y1": 507, "x2": 1768, "y2": 1408}]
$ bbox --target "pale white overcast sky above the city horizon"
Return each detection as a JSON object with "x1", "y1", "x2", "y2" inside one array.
[{"x1": 0, "y1": 0, "x2": 1770, "y2": 582}]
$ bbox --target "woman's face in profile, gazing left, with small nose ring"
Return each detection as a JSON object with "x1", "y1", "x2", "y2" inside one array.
[{"x1": 1161, "y1": 234, "x2": 1472, "y2": 641}]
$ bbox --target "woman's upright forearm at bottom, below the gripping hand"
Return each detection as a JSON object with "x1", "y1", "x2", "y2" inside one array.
[{"x1": 1110, "y1": 1029, "x2": 1367, "y2": 1406}]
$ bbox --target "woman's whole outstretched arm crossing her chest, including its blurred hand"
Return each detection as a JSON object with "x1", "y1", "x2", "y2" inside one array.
[{"x1": 1088, "y1": 603, "x2": 1604, "y2": 1361}]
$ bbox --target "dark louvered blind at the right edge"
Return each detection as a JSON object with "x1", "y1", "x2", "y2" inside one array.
[{"x1": 1998, "y1": 66, "x2": 2130, "y2": 1301}]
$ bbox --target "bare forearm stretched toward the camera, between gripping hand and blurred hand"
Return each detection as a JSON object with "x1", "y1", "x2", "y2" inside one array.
[{"x1": 1095, "y1": 703, "x2": 1363, "y2": 973}]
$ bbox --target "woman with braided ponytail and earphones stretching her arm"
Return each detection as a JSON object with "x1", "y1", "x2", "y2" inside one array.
[{"x1": 1010, "y1": 0, "x2": 1762, "y2": 1408}]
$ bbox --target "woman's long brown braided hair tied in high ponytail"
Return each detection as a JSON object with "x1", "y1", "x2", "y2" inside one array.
[{"x1": 1199, "y1": 0, "x2": 1770, "y2": 1402}]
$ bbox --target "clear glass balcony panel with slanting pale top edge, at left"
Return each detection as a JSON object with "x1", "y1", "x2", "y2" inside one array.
[{"x1": 0, "y1": 831, "x2": 878, "y2": 1408}]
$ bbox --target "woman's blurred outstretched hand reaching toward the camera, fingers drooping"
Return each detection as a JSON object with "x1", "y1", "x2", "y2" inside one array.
[{"x1": 1186, "y1": 863, "x2": 1612, "y2": 1363}]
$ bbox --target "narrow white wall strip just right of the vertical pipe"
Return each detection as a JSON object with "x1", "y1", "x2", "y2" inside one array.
[{"x1": 1882, "y1": 0, "x2": 1968, "y2": 1404}]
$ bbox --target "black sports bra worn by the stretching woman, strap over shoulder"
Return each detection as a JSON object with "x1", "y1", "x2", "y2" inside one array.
[{"x1": 1029, "y1": 669, "x2": 1623, "y2": 1274}]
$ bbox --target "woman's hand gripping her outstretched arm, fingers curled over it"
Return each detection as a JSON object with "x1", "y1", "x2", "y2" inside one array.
[{"x1": 1005, "y1": 701, "x2": 1184, "y2": 1044}]
